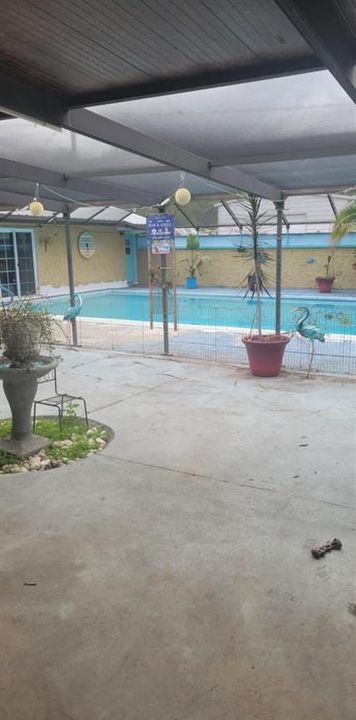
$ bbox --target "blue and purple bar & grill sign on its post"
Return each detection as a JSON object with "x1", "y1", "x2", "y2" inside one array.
[{"x1": 146, "y1": 208, "x2": 174, "y2": 355}]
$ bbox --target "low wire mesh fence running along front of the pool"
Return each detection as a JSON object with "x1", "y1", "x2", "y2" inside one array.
[{"x1": 52, "y1": 292, "x2": 356, "y2": 376}]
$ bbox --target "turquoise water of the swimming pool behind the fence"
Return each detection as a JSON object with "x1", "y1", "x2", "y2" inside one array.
[{"x1": 40, "y1": 290, "x2": 356, "y2": 335}]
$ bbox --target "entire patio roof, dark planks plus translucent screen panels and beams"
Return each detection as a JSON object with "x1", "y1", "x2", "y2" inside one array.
[{"x1": 0, "y1": 0, "x2": 356, "y2": 212}]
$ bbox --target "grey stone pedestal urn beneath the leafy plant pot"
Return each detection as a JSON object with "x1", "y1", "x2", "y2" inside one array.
[{"x1": 0, "y1": 356, "x2": 58, "y2": 457}]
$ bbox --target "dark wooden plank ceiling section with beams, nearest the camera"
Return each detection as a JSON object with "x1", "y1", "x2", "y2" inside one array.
[{"x1": 1, "y1": 0, "x2": 356, "y2": 114}]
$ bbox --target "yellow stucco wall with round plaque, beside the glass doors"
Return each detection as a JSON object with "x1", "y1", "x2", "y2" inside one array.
[{"x1": 36, "y1": 225, "x2": 126, "y2": 287}]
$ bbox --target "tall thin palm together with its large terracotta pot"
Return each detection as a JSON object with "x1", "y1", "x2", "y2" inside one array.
[{"x1": 241, "y1": 193, "x2": 290, "y2": 377}]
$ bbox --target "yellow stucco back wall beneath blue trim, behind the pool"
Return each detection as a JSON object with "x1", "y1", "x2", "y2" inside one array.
[{"x1": 138, "y1": 248, "x2": 356, "y2": 289}]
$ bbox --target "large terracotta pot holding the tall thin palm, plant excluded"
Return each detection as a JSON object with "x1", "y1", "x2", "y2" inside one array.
[{"x1": 242, "y1": 335, "x2": 290, "y2": 377}]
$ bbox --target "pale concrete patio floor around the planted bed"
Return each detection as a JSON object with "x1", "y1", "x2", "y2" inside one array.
[{"x1": 0, "y1": 350, "x2": 356, "y2": 720}]
